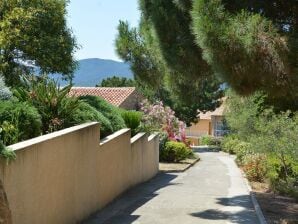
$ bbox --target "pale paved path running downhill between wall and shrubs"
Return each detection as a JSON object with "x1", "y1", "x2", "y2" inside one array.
[{"x1": 85, "y1": 148, "x2": 259, "y2": 224}]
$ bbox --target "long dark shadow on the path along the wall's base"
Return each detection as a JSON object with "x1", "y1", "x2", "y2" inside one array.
[{"x1": 81, "y1": 173, "x2": 178, "y2": 224}]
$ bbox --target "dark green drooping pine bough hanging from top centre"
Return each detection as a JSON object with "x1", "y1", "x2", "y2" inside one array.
[{"x1": 140, "y1": 0, "x2": 212, "y2": 81}]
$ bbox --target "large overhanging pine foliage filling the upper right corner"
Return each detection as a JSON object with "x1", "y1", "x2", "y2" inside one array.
[{"x1": 140, "y1": 0, "x2": 298, "y2": 109}]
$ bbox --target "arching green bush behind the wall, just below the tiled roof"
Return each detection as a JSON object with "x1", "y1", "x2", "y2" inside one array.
[{"x1": 79, "y1": 96, "x2": 126, "y2": 132}]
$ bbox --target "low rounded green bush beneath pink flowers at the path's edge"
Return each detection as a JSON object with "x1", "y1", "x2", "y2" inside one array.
[{"x1": 160, "y1": 141, "x2": 193, "y2": 162}]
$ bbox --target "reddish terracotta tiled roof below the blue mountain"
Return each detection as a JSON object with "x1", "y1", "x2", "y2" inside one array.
[{"x1": 69, "y1": 87, "x2": 136, "y2": 106}]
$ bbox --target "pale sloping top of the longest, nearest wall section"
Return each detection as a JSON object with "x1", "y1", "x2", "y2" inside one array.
[{"x1": 7, "y1": 122, "x2": 99, "y2": 151}]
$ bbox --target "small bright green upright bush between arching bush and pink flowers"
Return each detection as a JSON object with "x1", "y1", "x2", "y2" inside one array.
[{"x1": 121, "y1": 110, "x2": 142, "y2": 135}]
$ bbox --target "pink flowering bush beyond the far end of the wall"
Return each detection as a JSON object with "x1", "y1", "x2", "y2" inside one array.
[{"x1": 141, "y1": 100, "x2": 186, "y2": 142}]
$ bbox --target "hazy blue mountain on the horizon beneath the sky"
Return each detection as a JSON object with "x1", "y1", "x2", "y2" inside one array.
[{"x1": 54, "y1": 58, "x2": 133, "y2": 87}]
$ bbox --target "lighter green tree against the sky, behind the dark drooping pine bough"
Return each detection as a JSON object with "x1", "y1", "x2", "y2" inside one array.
[{"x1": 116, "y1": 17, "x2": 222, "y2": 125}]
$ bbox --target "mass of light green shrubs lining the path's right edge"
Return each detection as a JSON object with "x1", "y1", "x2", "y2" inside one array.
[{"x1": 223, "y1": 90, "x2": 298, "y2": 197}]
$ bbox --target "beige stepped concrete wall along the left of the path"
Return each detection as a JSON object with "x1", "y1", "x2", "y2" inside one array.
[{"x1": 0, "y1": 123, "x2": 159, "y2": 224}]
